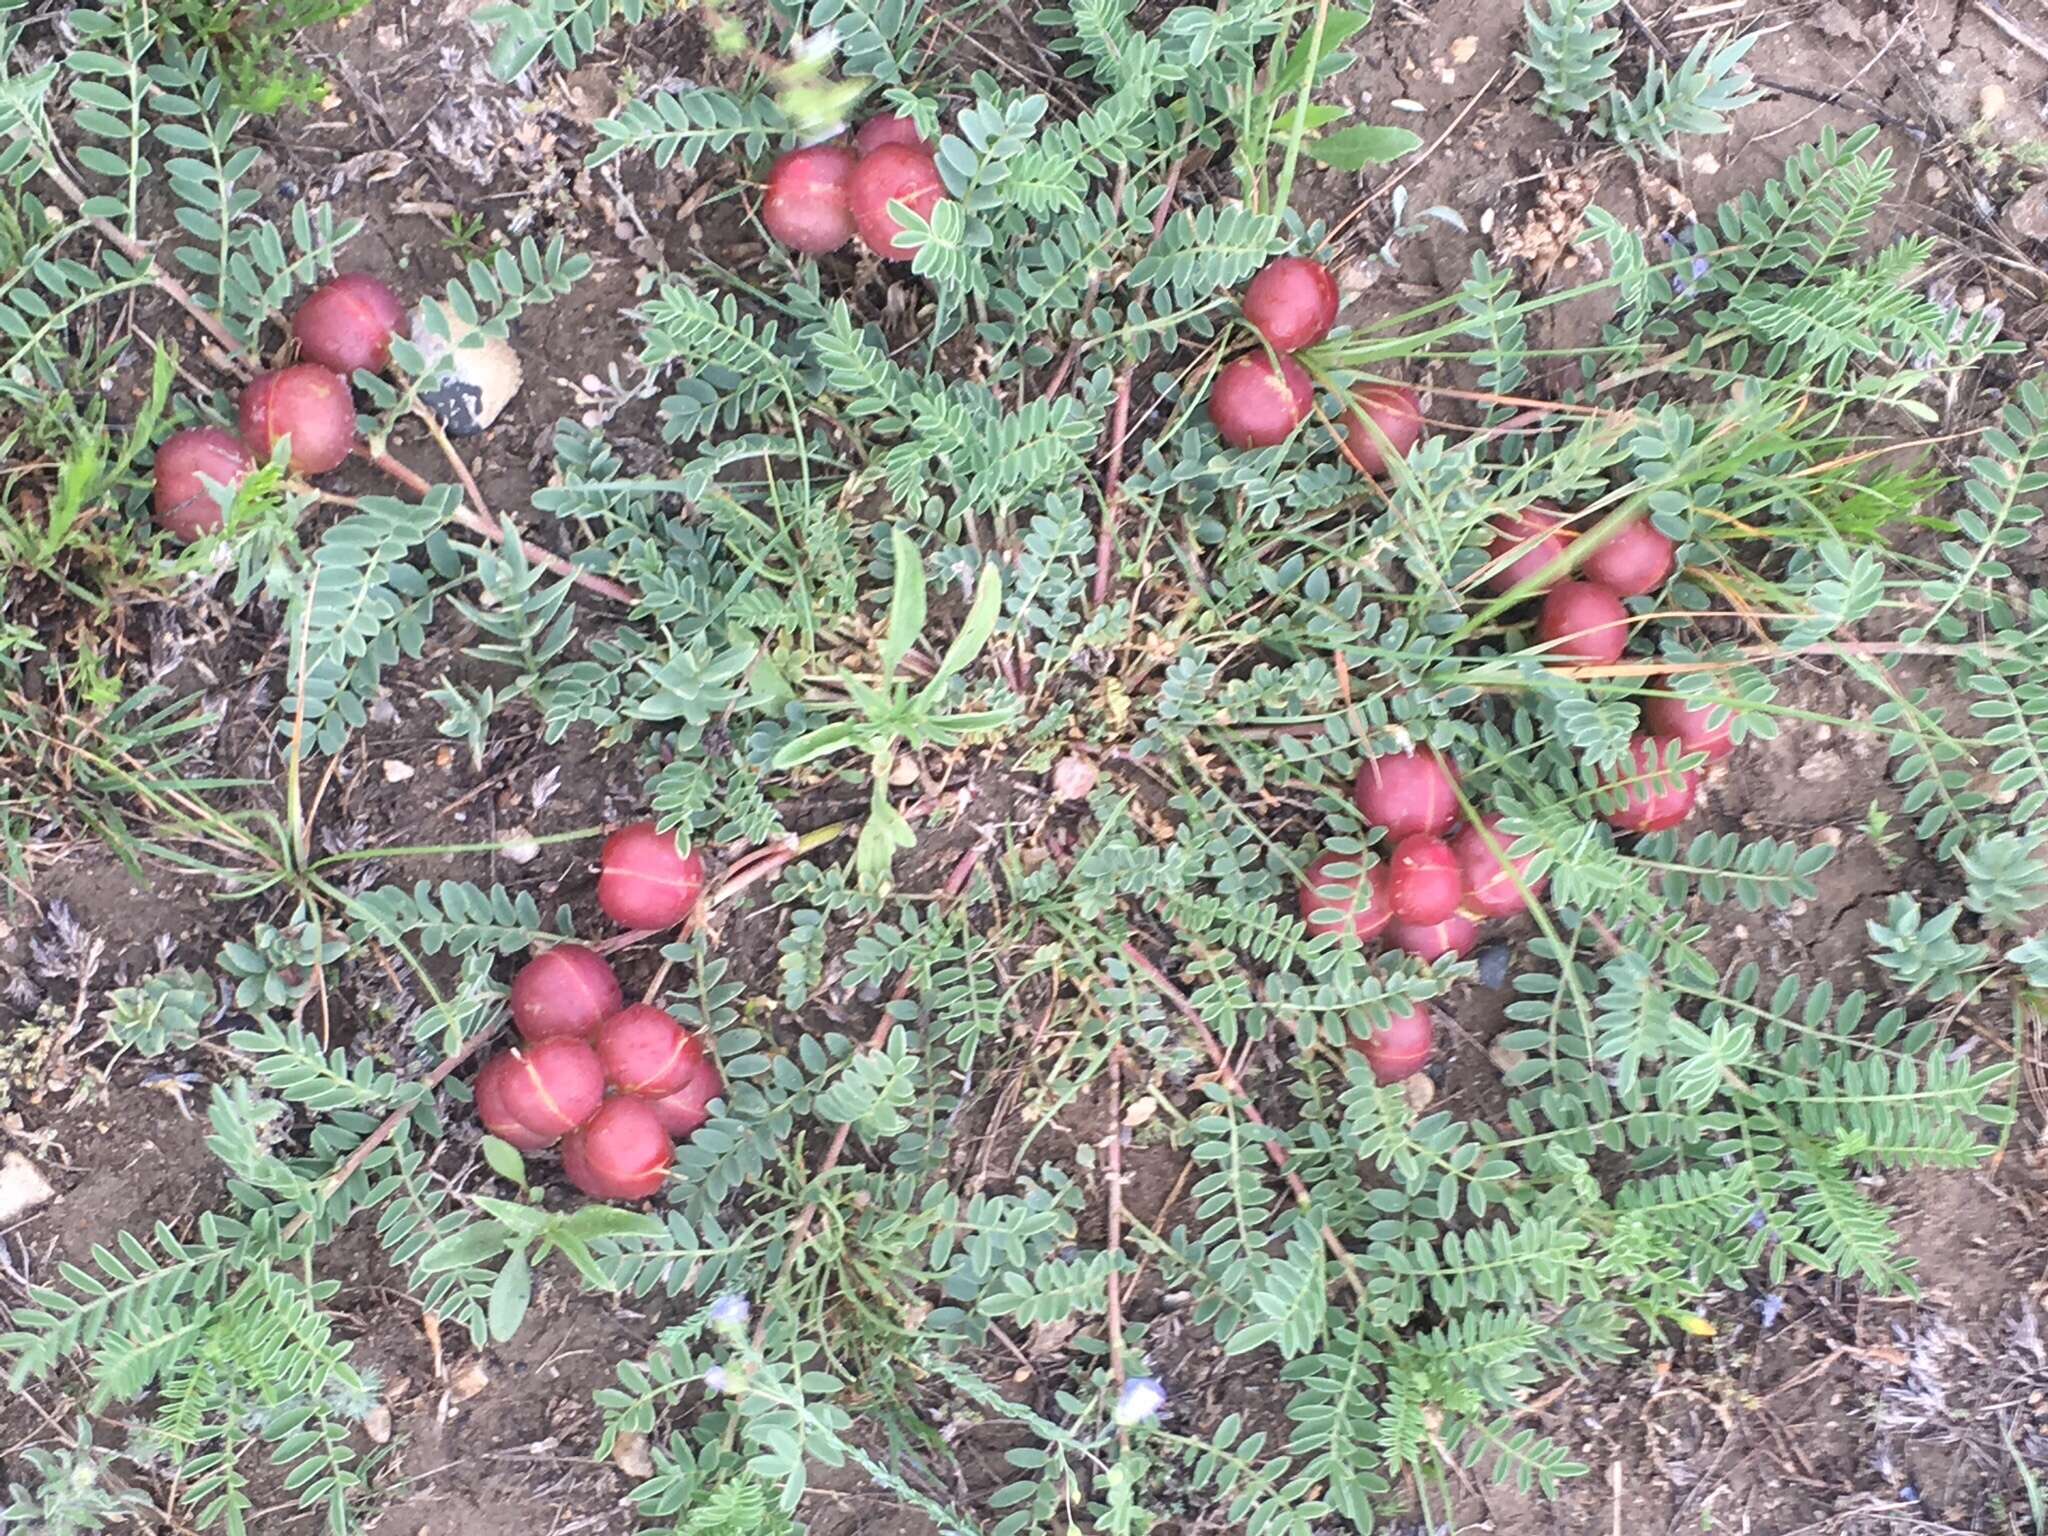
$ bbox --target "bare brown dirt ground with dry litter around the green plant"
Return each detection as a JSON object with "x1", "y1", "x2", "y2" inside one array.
[{"x1": 0, "y1": 0, "x2": 2048, "y2": 1536}]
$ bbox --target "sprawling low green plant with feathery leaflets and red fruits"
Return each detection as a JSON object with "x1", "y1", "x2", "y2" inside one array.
[{"x1": 0, "y1": 0, "x2": 2048, "y2": 1536}]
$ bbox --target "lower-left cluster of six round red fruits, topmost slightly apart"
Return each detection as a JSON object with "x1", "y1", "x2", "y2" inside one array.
[{"x1": 477, "y1": 821, "x2": 725, "y2": 1200}]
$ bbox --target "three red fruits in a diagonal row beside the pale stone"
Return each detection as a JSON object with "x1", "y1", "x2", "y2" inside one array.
[{"x1": 154, "y1": 272, "x2": 403, "y2": 543}]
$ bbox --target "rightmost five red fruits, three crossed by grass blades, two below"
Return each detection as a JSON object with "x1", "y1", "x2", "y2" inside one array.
[{"x1": 1487, "y1": 508, "x2": 1735, "y2": 831}]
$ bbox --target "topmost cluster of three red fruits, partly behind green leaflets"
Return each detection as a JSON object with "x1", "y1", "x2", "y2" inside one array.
[{"x1": 762, "y1": 115, "x2": 946, "y2": 262}]
